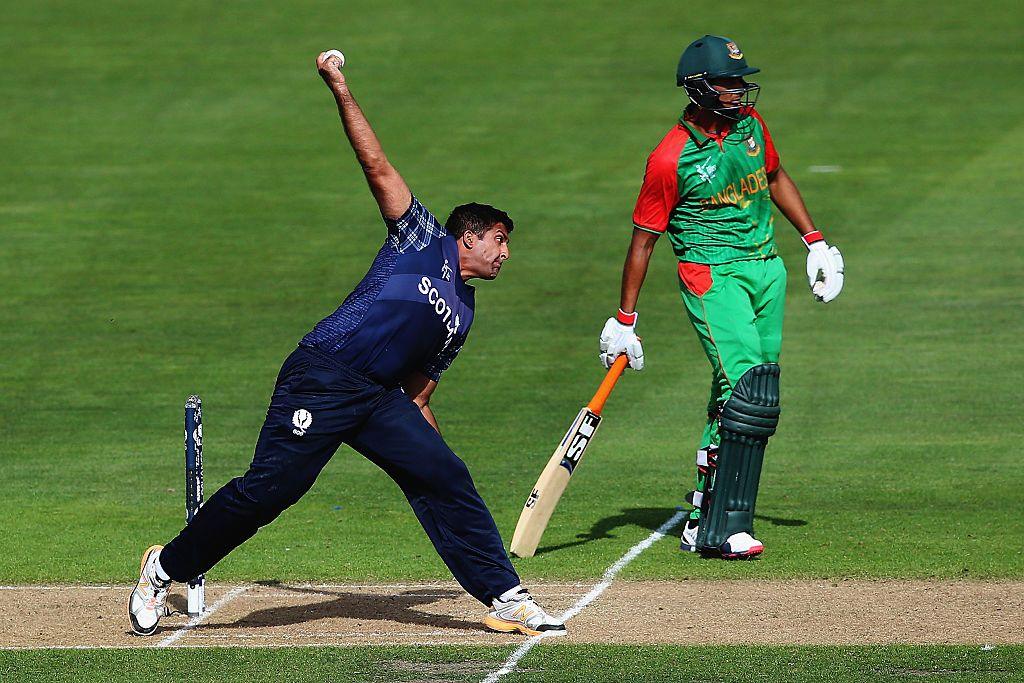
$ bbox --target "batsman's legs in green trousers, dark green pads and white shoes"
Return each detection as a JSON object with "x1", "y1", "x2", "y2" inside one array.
[{"x1": 680, "y1": 258, "x2": 785, "y2": 557}]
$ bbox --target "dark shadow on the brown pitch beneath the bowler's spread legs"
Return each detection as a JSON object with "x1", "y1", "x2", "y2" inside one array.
[{"x1": 205, "y1": 582, "x2": 483, "y2": 632}]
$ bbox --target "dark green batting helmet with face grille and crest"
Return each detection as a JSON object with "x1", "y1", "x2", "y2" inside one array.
[{"x1": 676, "y1": 36, "x2": 761, "y2": 121}]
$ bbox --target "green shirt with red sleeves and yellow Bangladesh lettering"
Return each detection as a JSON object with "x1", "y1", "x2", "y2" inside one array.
[{"x1": 633, "y1": 112, "x2": 779, "y2": 264}]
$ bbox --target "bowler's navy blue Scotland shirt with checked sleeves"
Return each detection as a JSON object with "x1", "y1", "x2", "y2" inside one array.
[{"x1": 299, "y1": 197, "x2": 474, "y2": 387}]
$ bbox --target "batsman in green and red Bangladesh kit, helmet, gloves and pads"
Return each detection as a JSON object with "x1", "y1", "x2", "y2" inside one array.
[{"x1": 600, "y1": 36, "x2": 844, "y2": 559}]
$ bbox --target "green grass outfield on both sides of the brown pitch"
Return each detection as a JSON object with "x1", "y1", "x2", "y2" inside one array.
[{"x1": 0, "y1": 0, "x2": 1024, "y2": 681}]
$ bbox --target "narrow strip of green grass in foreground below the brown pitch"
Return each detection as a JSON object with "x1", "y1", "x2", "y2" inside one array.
[{"x1": 0, "y1": 645, "x2": 1024, "y2": 683}]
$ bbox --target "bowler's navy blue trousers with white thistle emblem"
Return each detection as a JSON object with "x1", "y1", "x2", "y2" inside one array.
[{"x1": 160, "y1": 347, "x2": 519, "y2": 605}]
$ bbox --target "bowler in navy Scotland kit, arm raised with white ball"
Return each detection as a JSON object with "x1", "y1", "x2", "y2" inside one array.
[{"x1": 128, "y1": 50, "x2": 565, "y2": 635}]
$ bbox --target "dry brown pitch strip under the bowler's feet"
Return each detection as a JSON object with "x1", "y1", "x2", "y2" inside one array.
[{"x1": 0, "y1": 581, "x2": 1024, "y2": 648}]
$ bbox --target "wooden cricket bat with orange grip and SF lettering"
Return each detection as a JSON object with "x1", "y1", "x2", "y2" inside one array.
[{"x1": 509, "y1": 355, "x2": 629, "y2": 557}]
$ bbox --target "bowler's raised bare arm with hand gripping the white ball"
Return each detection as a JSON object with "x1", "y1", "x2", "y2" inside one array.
[{"x1": 316, "y1": 52, "x2": 413, "y2": 219}]
